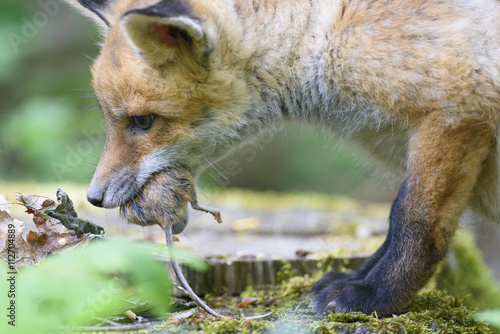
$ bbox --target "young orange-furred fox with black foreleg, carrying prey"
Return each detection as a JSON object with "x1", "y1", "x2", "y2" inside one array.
[{"x1": 66, "y1": 0, "x2": 500, "y2": 315}]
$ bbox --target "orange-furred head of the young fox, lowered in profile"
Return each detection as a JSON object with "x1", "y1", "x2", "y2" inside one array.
[{"x1": 67, "y1": 0, "x2": 272, "y2": 208}]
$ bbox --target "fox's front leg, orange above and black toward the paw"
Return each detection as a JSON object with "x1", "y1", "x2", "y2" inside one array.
[{"x1": 312, "y1": 113, "x2": 495, "y2": 315}]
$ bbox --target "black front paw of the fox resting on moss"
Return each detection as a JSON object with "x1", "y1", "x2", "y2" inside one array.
[{"x1": 312, "y1": 274, "x2": 400, "y2": 315}]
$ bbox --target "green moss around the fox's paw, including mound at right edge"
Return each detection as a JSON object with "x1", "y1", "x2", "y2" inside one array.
[{"x1": 155, "y1": 233, "x2": 500, "y2": 334}]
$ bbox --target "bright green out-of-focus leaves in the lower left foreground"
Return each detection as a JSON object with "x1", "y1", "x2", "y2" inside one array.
[{"x1": 0, "y1": 240, "x2": 176, "y2": 333}]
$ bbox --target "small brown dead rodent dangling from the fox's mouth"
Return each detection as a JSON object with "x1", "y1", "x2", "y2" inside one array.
[{"x1": 120, "y1": 166, "x2": 222, "y2": 234}]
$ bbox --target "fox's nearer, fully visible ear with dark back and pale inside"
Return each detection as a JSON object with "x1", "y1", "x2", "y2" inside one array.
[{"x1": 123, "y1": 0, "x2": 215, "y2": 65}]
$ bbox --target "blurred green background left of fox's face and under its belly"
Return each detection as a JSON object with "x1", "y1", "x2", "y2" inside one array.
[{"x1": 0, "y1": 0, "x2": 390, "y2": 198}]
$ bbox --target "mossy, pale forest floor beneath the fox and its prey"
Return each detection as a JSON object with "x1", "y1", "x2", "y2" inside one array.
[{"x1": 0, "y1": 185, "x2": 500, "y2": 334}]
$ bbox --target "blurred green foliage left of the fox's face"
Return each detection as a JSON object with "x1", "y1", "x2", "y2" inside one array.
[{"x1": 0, "y1": 0, "x2": 104, "y2": 181}]
